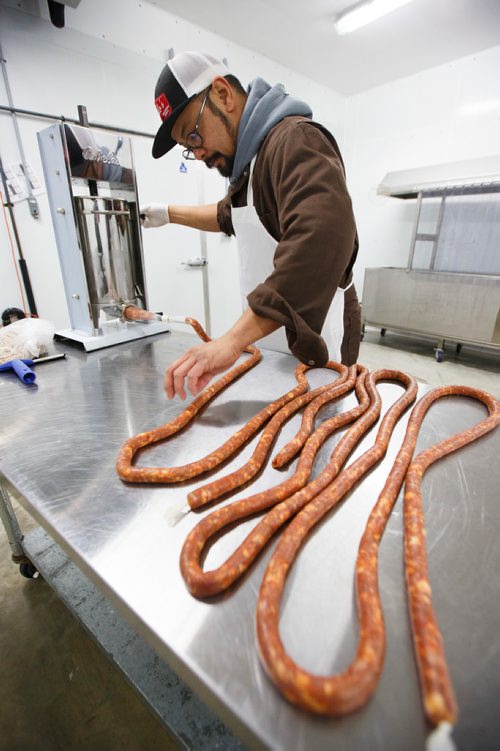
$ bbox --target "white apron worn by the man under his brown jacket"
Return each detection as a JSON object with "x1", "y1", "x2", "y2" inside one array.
[{"x1": 231, "y1": 157, "x2": 352, "y2": 365}]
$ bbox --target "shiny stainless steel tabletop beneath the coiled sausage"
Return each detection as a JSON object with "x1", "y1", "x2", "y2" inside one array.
[{"x1": 0, "y1": 332, "x2": 500, "y2": 751}]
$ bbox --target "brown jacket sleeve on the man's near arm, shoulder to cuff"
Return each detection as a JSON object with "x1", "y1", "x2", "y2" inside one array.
[{"x1": 247, "y1": 121, "x2": 356, "y2": 365}]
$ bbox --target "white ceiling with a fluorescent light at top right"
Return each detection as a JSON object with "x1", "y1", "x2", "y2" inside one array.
[{"x1": 154, "y1": 0, "x2": 500, "y2": 95}]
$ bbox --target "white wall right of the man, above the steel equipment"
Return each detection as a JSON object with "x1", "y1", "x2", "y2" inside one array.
[{"x1": 344, "y1": 46, "x2": 500, "y2": 292}]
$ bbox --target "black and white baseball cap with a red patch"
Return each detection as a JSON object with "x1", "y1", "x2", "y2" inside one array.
[{"x1": 152, "y1": 52, "x2": 229, "y2": 159}]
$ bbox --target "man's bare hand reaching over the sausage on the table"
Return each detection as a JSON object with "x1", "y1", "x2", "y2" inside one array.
[{"x1": 164, "y1": 334, "x2": 244, "y2": 399}]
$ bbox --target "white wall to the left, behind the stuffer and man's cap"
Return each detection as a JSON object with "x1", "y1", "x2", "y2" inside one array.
[{"x1": 0, "y1": 0, "x2": 345, "y2": 335}]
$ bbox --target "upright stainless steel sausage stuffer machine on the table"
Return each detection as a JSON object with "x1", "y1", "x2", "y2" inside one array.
[{"x1": 38, "y1": 123, "x2": 169, "y2": 350}]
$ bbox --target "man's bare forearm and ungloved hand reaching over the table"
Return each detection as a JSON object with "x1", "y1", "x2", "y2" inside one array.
[{"x1": 164, "y1": 308, "x2": 280, "y2": 399}]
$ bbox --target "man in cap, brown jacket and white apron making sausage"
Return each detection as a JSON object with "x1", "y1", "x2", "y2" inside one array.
[{"x1": 141, "y1": 52, "x2": 360, "y2": 399}]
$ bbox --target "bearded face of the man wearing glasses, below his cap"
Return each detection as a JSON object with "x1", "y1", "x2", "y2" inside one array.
[{"x1": 172, "y1": 89, "x2": 237, "y2": 177}]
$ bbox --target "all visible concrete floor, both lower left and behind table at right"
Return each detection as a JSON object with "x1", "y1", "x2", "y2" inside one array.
[{"x1": 0, "y1": 329, "x2": 500, "y2": 751}]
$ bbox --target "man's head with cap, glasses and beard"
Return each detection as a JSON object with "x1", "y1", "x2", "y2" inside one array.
[{"x1": 153, "y1": 52, "x2": 246, "y2": 177}]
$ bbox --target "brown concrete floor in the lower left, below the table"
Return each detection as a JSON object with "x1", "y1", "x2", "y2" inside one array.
[{"x1": 0, "y1": 499, "x2": 179, "y2": 751}]
